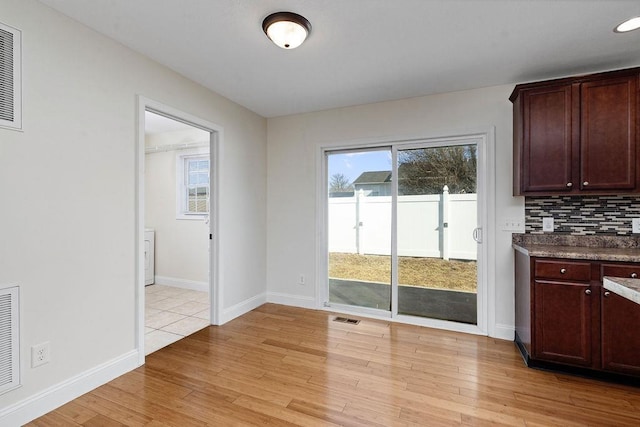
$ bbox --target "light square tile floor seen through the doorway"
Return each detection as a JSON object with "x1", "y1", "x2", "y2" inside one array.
[{"x1": 144, "y1": 285, "x2": 210, "y2": 354}]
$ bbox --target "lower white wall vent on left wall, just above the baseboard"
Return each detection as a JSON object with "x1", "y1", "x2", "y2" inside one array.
[{"x1": 0, "y1": 286, "x2": 20, "y2": 394}]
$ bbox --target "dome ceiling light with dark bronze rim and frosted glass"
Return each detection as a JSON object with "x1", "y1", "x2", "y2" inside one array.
[{"x1": 262, "y1": 12, "x2": 311, "y2": 49}]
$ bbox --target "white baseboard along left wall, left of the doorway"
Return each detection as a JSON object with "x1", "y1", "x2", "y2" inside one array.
[{"x1": 0, "y1": 350, "x2": 138, "y2": 427}]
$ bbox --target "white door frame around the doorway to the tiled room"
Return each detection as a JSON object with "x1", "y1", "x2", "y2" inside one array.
[{"x1": 135, "y1": 95, "x2": 223, "y2": 366}]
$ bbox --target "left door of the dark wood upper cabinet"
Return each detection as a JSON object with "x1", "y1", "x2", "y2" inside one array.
[{"x1": 521, "y1": 85, "x2": 577, "y2": 193}]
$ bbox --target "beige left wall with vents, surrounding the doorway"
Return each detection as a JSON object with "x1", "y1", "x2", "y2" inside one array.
[{"x1": 0, "y1": 0, "x2": 266, "y2": 414}]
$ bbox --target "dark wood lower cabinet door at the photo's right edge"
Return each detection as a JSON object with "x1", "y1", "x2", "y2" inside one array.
[{"x1": 601, "y1": 290, "x2": 640, "y2": 375}]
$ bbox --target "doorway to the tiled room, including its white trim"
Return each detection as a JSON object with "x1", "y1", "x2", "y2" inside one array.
[{"x1": 137, "y1": 98, "x2": 221, "y2": 364}]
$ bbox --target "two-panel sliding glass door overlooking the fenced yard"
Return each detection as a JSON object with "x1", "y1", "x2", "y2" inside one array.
[{"x1": 325, "y1": 138, "x2": 481, "y2": 324}]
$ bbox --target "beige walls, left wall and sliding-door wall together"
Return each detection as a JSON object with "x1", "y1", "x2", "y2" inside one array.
[{"x1": 0, "y1": 0, "x2": 523, "y2": 422}]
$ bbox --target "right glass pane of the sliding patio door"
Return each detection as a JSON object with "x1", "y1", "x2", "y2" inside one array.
[{"x1": 397, "y1": 144, "x2": 478, "y2": 324}]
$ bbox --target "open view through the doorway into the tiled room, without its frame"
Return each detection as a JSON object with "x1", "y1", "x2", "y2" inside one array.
[{"x1": 144, "y1": 110, "x2": 210, "y2": 355}]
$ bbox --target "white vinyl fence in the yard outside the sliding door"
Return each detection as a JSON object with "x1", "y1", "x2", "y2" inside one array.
[{"x1": 329, "y1": 187, "x2": 477, "y2": 260}]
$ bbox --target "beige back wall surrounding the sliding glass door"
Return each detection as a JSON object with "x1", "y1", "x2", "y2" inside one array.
[{"x1": 267, "y1": 85, "x2": 524, "y2": 339}]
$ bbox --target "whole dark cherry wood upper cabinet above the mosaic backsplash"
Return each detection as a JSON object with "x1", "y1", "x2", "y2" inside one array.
[{"x1": 510, "y1": 69, "x2": 640, "y2": 195}]
